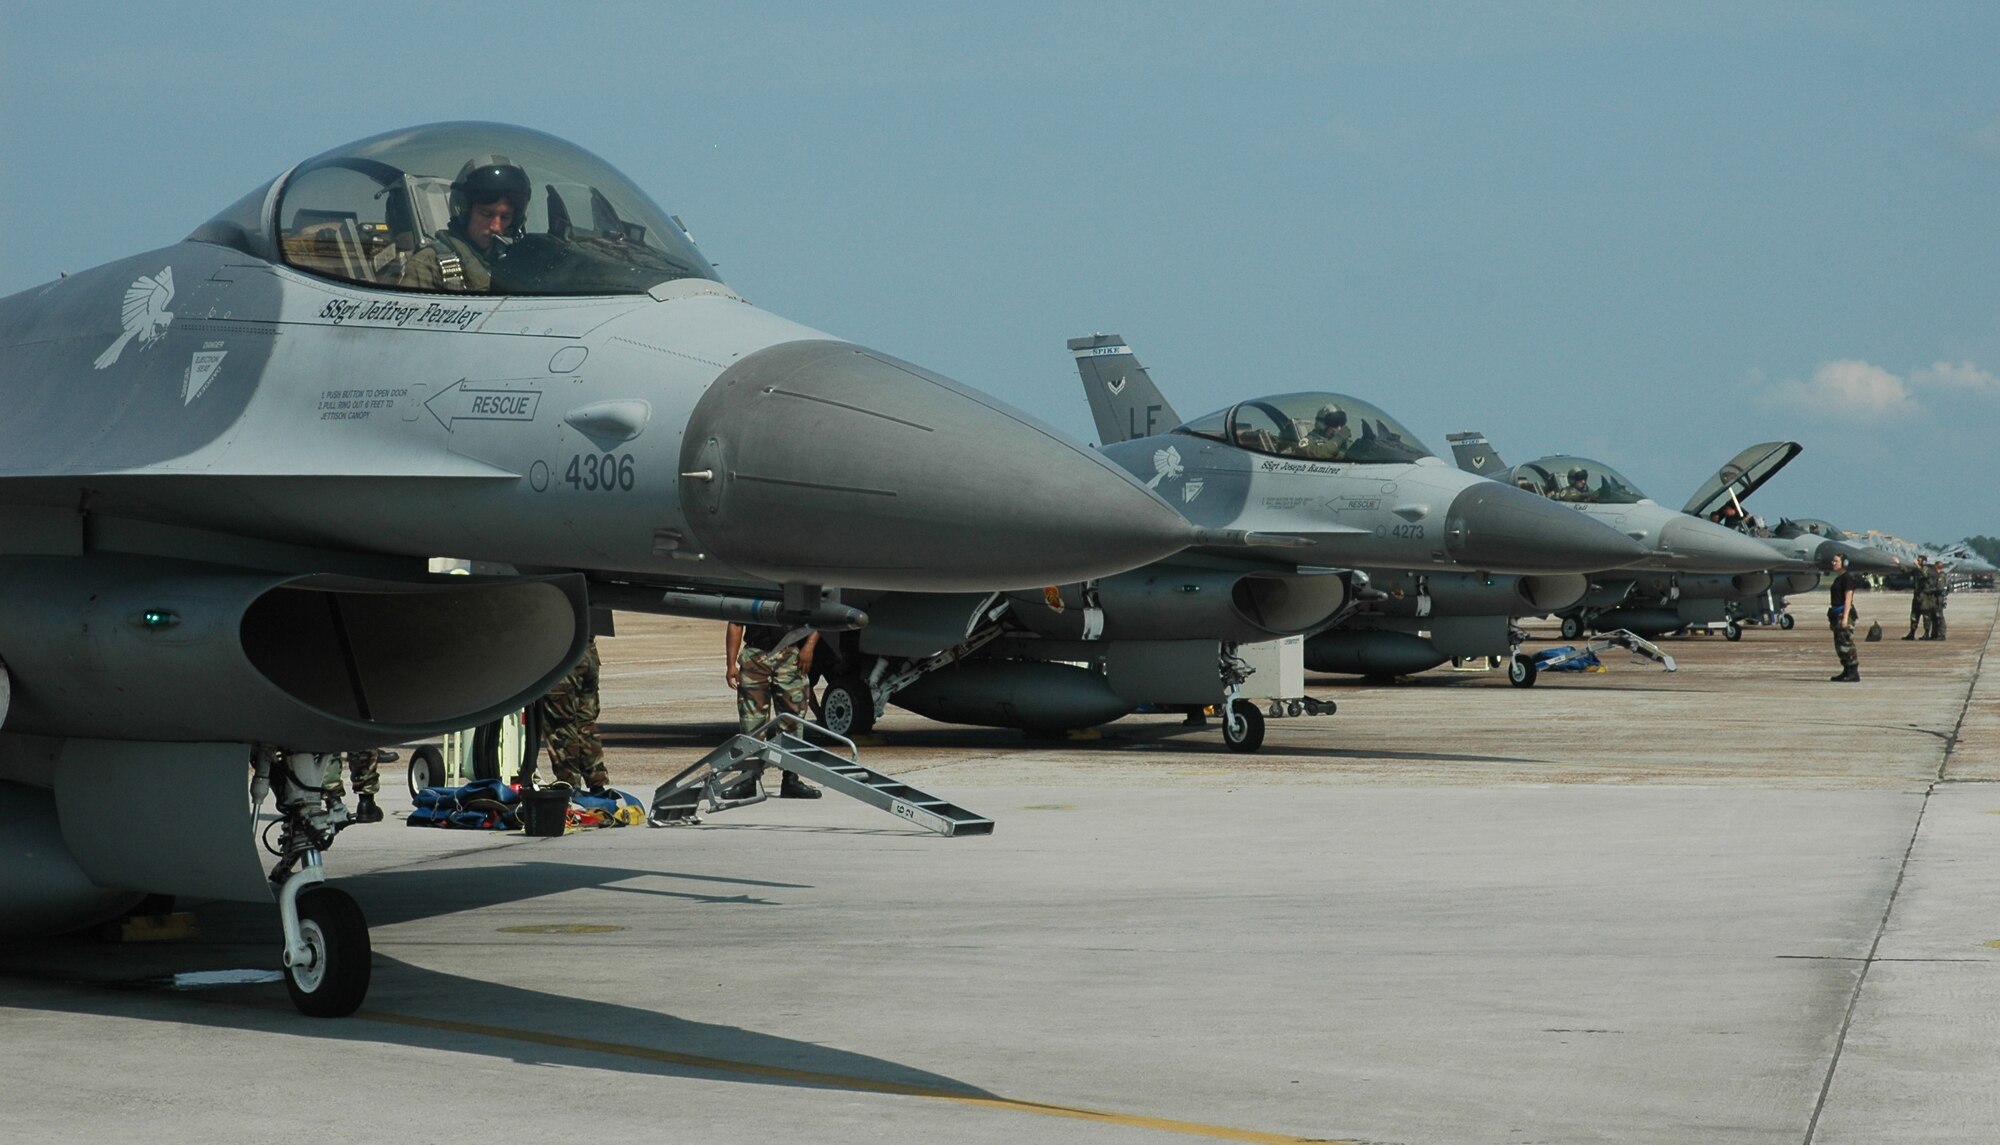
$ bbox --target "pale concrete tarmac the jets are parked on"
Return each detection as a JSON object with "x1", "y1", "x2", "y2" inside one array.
[{"x1": 0, "y1": 593, "x2": 2000, "y2": 1145}]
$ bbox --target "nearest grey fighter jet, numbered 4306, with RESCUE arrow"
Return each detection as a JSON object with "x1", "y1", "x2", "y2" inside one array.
[{"x1": 0, "y1": 124, "x2": 1200, "y2": 1015}]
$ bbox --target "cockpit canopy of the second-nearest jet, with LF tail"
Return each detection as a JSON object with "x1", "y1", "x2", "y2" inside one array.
[{"x1": 1174, "y1": 390, "x2": 1432, "y2": 464}]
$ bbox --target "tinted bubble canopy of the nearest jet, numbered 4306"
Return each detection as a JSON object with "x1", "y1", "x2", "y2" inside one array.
[{"x1": 190, "y1": 122, "x2": 716, "y2": 294}]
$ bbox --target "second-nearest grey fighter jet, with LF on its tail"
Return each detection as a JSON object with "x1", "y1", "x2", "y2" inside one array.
[{"x1": 788, "y1": 334, "x2": 1644, "y2": 751}]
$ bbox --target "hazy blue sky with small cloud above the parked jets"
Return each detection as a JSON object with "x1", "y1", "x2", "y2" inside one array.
[{"x1": 0, "y1": 0, "x2": 2000, "y2": 540}]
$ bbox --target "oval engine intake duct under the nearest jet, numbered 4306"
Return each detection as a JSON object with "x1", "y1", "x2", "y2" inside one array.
[{"x1": 0, "y1": 554, "x2": 590, "y2": 751}]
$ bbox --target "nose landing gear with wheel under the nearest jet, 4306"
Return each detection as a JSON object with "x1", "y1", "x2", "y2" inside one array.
[{"x1": 254, "y1": 747, "x2": 370, "y2": 1017}]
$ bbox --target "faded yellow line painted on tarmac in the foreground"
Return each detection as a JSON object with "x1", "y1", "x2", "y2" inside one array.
[{"x1": 366, "y1": 1009, "x2": 1340, "y2": 1145}]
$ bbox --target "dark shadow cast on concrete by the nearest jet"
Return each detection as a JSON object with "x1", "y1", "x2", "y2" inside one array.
[{"x1": 0, "y1": 863, "x2": 992, "y2": 1097}]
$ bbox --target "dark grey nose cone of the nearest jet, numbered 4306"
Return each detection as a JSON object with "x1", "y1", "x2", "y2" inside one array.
[{"x1": 680, "y1": 340, "x2": 1194, "y2": 593}]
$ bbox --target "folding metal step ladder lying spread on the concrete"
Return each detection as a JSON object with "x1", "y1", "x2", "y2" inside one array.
[{"x1": 646, "y1": 713, "x2": 994, "y2": 835}]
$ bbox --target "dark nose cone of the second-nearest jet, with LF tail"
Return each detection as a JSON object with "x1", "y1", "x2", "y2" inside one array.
[{"x1": 1444, "y1": 480, "x2": 1646, "y2": 573}]
